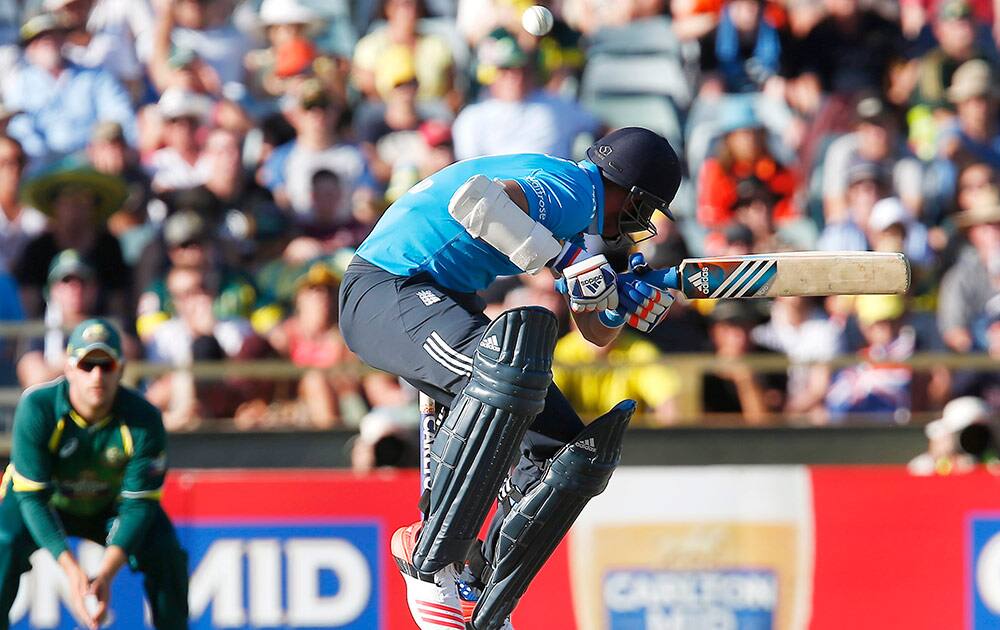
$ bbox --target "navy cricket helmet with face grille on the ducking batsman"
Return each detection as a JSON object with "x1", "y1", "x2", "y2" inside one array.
[{"x1": 587, "y1": 127, "x2": 681, "y2": 243}]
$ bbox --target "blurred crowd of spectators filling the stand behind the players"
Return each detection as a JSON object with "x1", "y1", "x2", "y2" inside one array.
[{"x1": 0, "y1": 0, "x2": 1000, "y2": 437}]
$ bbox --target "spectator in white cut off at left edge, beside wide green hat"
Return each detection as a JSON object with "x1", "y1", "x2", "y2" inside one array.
[{"x1": 0, "y1": 136, "x2": 47, "y2": 271}]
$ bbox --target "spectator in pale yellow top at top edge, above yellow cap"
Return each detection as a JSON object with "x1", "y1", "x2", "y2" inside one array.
[{"x1": 353, "y1": 0, "x2": 460, "y2": 108}]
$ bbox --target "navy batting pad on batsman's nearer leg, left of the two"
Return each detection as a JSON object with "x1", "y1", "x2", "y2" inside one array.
[{"x1": 413, "y1": 307, "x2": 558, "y2": 574}]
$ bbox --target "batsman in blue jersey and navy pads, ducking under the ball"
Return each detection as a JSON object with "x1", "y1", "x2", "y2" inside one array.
[{"x1": 340, "y1": 127, "x2": 681, "y2": 630}]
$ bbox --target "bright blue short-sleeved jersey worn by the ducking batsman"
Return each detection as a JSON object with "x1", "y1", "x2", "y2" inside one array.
[{"x1": 357, "y1": 153, "x2": 604, "y2": 293}]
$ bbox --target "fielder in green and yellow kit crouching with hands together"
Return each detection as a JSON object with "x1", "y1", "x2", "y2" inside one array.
[{"x1": 0, "y1": 319, "x2": 188, "y2": 630}]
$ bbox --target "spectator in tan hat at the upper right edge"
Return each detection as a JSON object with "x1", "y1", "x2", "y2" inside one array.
[{"x1": 941, "y1": 59, "x2": 1000, "y2": 169}]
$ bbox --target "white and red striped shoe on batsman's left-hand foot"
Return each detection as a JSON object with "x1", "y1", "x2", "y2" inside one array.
[{"x1": 390, "y1": 521, "x2": 466, "y2": 630}]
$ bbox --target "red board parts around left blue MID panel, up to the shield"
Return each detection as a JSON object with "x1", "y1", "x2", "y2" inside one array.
[{"x1": 163, "y1": 470, "x2": 576, "y2": 630}]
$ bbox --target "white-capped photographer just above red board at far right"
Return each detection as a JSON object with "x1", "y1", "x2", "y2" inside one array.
[{"x1": 906, "y1": 396, "x2": 996, "y2": 476}]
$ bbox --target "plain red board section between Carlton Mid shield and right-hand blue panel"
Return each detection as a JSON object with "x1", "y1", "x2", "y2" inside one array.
[{"x1": 810, "y1": 466, "x2": 1000, "y2": 630}]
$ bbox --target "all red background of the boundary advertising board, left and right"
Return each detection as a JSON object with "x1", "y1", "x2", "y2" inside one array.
[{"x1": 164, "y1": 466, "x2": 1000, "y2": 630}]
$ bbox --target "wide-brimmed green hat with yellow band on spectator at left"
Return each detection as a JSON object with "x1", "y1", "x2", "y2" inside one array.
[{"x1": 24, "y1": 158, "x2": 128, "y2": 218}]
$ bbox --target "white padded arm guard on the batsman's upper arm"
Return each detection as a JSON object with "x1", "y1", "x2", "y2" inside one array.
[{"x1": 448, "y1": 175, "x2": 562, "y2": 274}]
